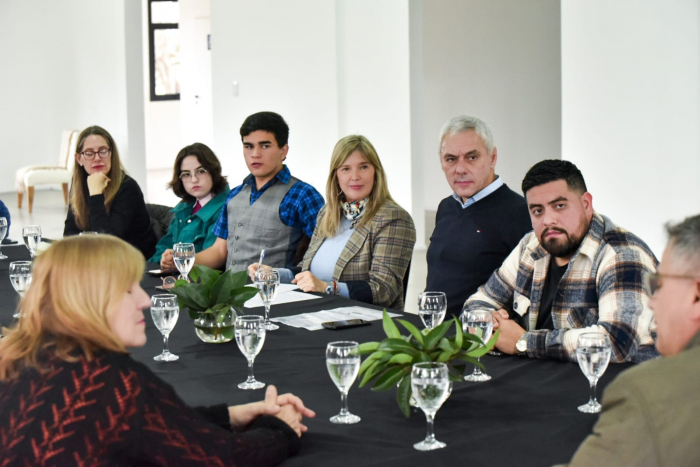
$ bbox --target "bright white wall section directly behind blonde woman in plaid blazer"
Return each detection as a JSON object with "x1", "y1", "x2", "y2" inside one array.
[{"x1": 336, "y1": 0, "x2": 412, "y2": 212}]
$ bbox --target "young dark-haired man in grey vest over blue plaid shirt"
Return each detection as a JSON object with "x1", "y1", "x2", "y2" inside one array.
[{"x1": 164, "y1": 112, "x2": 324, "y2": 272}]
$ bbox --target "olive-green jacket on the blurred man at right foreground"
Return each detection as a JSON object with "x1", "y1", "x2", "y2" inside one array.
[{"x1": 570, "y1": 332, "x2": 700, "y2": 467}]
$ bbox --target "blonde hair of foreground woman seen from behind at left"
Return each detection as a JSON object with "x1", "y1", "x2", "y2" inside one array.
[{"x1": 0, "y1": 235, "x2": 145, "y2": 381}]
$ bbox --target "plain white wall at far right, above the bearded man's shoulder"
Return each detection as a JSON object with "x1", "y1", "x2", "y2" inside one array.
[{"x1": 562, "y1": 0, "x2": 700, "y2": 256}]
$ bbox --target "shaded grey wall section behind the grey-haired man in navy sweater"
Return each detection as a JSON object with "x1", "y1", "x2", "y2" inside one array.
[{"x1": 411, "y1": 0, "x2": 561, "y2": 245}]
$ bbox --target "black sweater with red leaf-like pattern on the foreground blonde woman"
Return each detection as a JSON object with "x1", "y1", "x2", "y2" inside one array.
[{"x1": 0, "y1": 353, "x2": 300, "y2": 467}]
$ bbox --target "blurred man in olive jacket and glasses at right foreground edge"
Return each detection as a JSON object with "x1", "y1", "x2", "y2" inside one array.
[{"x1": 556, "y1": 215, "x2": 700, "y2": 467}]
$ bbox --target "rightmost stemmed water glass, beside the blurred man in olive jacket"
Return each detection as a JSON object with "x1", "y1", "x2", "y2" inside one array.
[{"x1": 576, "y1": 332, "x2": 612, "y2": 413}]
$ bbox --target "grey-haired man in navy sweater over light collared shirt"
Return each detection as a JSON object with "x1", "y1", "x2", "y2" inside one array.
[{"x1": 426, "y1": 115, "x2": 532, "y2": 316}]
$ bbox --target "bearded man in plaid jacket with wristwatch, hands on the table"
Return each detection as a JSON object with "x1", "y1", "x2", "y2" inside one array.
[{"x1": 464, "y1": 160, "x2": 658, "y2": 362}]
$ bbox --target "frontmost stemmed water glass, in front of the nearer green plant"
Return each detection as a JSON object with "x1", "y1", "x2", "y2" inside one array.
[{"x1": 411, "y1": 362, "x2": 451, "y2": 451}]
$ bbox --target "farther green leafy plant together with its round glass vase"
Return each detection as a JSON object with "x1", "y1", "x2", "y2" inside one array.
[{"x1": 171, "y1": 265, "x2": 258, "y2": 343}]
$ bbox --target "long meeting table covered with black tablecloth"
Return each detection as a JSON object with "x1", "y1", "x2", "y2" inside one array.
[{"x1": 0, "y1": 244, "x2": 630, "y2": 467}]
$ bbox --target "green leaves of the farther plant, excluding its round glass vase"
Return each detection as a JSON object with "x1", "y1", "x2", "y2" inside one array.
[{"x1": 170, "y1": 264, "x2": 258, "y2": 334}]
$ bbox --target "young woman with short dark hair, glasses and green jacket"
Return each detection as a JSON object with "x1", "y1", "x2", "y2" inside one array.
[{"x1": 148, "y1": 143, "x2": 230, "y2": 270}]
